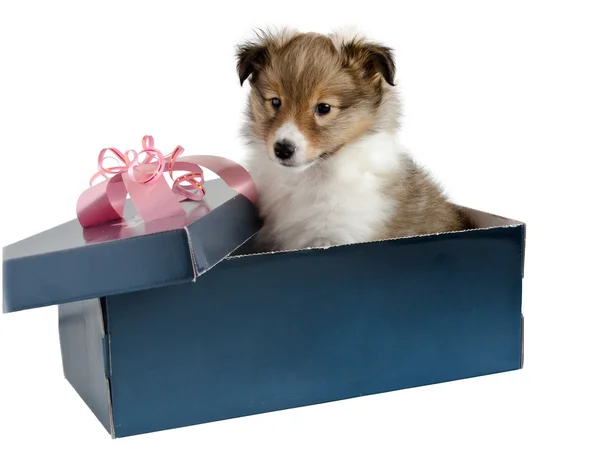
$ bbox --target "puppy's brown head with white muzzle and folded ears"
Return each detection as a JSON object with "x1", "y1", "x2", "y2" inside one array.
[{"x1": 237, "y1": 30, "x2": 395, "y2": 168}]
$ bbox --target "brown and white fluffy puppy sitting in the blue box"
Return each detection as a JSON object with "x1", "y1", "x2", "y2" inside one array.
[{"x1": 237, "y1": 30, "x2": 470, "y2": 251}]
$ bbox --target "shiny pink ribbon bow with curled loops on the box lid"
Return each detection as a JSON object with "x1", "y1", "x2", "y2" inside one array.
[{"x1": 77, "y1": 136, "x2": 257, "y2": 228}]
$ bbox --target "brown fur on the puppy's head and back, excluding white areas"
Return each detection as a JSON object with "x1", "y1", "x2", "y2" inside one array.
[{"x1": 237, "y1": 28, "x2": 471, "y2": 246}]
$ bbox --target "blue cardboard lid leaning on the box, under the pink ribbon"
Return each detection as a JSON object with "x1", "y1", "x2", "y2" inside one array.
[{"x1": 3, "y1": 179, "x2": 261, "y2": 313}]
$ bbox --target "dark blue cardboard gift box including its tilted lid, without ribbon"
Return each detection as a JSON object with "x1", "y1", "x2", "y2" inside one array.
[{"x1": 3, "y1": 180, "x2": 525, "y2": 438}]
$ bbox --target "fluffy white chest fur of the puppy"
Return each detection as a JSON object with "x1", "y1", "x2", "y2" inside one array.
[{"x1": 246, "y1": 133, "x2": 403, "y2": 250}]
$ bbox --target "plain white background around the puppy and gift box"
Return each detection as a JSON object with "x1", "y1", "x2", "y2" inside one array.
[{"x1": 0, "y1": 0, "x2": 600, "y2": 449}]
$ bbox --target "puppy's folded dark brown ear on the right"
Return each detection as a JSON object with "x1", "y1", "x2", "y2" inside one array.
[{"x1": 342, "y1": 40, "x2": 396, "y2": 86}]
